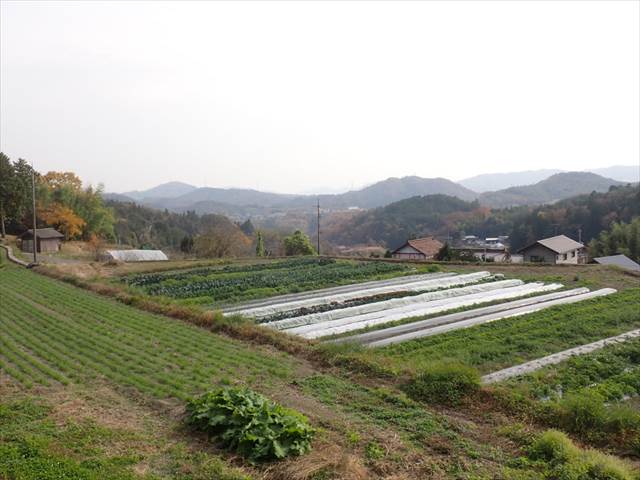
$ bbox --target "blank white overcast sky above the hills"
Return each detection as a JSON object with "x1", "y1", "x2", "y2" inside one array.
[{"x1": 0, "y1": 0, "x2": 640, "y2": 192}]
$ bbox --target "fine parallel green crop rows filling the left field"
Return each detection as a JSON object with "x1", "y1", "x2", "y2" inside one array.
[{"x1": 0, "y1": 268, "x2": 293, "y2": 398}]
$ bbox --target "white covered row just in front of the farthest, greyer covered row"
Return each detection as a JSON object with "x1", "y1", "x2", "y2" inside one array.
[{"x1": 236, "y1": 272, "x2": 491, "y2": 318}]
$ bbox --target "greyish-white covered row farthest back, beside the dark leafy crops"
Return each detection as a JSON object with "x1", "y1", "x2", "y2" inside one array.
[{"x1": 224, "y1": 273, "x2": 456, "y2": 314}]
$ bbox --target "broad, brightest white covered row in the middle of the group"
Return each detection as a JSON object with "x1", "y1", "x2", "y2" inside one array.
[{"x1": 286, "y1": 280, "x2": 562, "y2": 338}]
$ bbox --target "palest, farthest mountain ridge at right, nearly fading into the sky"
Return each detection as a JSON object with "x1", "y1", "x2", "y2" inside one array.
[{"x1": 458, "y1": 165, "x2": 640, "y2": 193}]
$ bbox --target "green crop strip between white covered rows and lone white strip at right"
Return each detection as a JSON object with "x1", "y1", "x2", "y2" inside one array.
[{"x1": 356, "y1": 289, "x2": 640, "y2": 373}]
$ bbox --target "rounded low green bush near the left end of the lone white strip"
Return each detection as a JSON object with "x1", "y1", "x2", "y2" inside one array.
[{"x1": 405, "y1": 363, "x2": 480, "y2": 405}]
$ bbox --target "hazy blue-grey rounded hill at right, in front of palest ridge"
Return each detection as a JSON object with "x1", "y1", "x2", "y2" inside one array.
[{"x1": 479, "y1": 172, "x2": 623, "y2": 208}]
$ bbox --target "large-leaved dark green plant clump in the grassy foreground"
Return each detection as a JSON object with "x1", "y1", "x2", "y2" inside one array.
[{"x1": 187, "y1": 387, "x2": 315, "y2": 463}]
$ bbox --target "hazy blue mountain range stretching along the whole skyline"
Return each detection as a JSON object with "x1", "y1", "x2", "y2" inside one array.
[{"x1": 105, "y1": 167, "x2": 637, "y2": 219}]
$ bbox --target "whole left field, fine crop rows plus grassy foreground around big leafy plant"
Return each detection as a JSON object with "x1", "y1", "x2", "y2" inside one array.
[{"x1": 0, "y1": 253, "x2": 540, "y2": 478}]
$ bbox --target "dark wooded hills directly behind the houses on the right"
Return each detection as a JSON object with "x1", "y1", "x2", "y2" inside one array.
[{"x1": 323, "y1": 185, "x2": 640, "y2": 251}]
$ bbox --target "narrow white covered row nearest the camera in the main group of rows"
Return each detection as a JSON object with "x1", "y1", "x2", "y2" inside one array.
[{"x1": 366, "y1": 288, "x2": 616, "y2": 347}]
